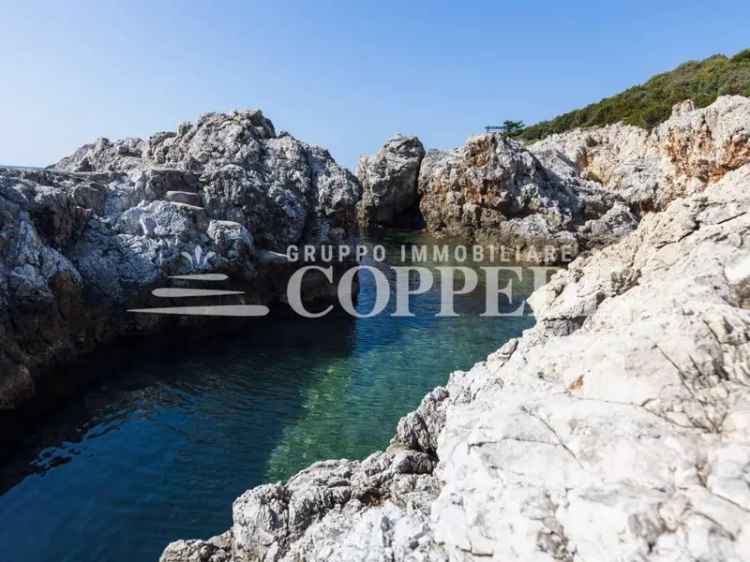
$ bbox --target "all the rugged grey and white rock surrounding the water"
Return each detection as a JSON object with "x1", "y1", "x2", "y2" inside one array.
[{"x1": 0, "y1": 96, "x2": 750, "y2": 562}]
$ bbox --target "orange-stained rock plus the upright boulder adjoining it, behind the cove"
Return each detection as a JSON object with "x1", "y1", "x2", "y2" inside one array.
[{"x1": 357, "y1": 129, "x2": 637, "y2": 262}]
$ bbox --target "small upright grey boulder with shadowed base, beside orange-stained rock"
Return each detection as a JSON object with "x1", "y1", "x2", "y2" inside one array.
[{"x1": 357, "y1": 134, "x2": 425, "y2": 226}]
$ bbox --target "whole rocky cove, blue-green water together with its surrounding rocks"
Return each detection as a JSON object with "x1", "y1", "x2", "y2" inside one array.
[{"x1": 0, "y1": 85, "x2": 750, "y2": 562}]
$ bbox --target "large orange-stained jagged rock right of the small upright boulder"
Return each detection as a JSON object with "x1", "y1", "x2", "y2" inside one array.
[{"x1": 419, "y1": 134, "x2": 636, "y2": 262}]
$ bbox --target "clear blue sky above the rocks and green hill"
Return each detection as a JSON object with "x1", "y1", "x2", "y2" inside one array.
[{"x1": 0, "y1": 0, "x2": 750, "y2": 168}]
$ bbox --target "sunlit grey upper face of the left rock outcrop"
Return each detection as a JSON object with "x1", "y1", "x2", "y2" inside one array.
[{"x1": 54, "y1": 111, "x2": 361, "y2": 251}]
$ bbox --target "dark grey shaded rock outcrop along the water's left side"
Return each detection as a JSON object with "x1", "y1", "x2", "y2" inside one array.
[{"x1": 0, "y1": 111, "x2": 361, "y2": 437}]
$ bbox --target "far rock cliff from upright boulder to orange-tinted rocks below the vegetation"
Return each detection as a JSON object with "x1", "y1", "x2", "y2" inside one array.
[{"x1": 358, "y1": 96, "x2": 750, "y2": 261}]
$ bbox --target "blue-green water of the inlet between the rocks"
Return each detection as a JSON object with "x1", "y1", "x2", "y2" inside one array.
[{"x1": 0, "y1": 234, "x2": 533, "y2": 562}]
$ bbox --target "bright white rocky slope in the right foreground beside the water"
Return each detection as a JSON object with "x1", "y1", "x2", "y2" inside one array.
[{"x1": 162, "y1": 154, "x2": 750, "y2": 562}]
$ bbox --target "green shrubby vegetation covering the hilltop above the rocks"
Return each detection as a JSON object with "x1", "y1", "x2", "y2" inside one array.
[{"x1": 514, "y1": 49, "x2": 750, "y2": 141}]
